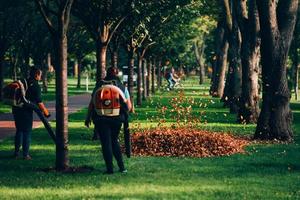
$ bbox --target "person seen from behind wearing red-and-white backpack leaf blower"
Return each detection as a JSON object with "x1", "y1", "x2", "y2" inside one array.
[{"x1": 85, "y1": 67, "x2": 132, "y2": 174}]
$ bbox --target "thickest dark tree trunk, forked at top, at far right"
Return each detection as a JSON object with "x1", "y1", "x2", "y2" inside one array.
[{"x1": 254, "y1": 0, "x2": 298, "y2": 141}]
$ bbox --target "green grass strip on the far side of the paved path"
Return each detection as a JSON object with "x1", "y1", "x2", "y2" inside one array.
[{"x1": 0, "y1": 77, "x2": 95, "y2": 113}]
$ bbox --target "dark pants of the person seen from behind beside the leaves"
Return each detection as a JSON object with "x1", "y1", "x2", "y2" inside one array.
[{"x1": 95, "y1": 119, "x2": 125, "y2": 172}]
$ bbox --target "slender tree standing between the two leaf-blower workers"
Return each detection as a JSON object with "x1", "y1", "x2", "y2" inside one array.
[{"x1": 35, "y1": 0, "x2": 73, "y2": 171}]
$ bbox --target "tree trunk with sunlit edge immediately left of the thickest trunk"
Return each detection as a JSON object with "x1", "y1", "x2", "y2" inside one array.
[{"x1": 238, "y1": 0, "x2": 260, "y2": 123}]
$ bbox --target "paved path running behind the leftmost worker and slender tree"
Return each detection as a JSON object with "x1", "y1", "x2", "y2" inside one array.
[{"x1": 0, "y1": 94, "x2": 91, "y2": 142}]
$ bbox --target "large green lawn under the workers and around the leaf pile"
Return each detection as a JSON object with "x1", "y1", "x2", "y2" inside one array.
[{"x1": 0, "y1": 76, "x2": 300, "y2": 199}]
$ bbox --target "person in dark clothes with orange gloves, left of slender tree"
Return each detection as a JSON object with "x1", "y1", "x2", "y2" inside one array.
[{"x1": 12, "y1": 67, "x2": 50, "y2": 160}]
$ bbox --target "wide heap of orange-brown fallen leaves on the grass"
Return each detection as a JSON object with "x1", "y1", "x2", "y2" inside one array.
[{"x1": 131, "y1": 128, "x2": 250, "y2": 157}]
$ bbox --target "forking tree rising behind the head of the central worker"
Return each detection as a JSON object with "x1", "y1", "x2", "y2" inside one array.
[{"x1": 73, "y1": 0, "x2": 133, "y2": 81}]
